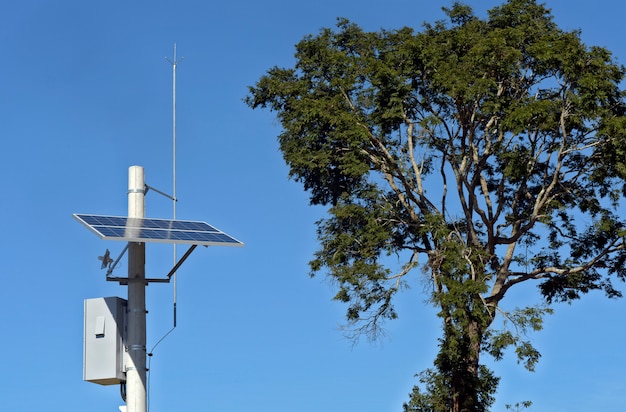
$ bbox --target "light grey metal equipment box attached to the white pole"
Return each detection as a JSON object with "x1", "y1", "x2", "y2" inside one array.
[{"x1": 83, "y1": 297, "x2": 127, "y2": 385}]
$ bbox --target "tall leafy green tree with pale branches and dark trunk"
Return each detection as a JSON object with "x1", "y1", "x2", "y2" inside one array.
[{"x1": 246, "y1": 0, "x2": 626, "y2": 412}]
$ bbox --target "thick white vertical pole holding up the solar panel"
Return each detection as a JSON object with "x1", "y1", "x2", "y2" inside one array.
[{"x1": 126, "y1": 166, "x2": 147, "y2": 412}]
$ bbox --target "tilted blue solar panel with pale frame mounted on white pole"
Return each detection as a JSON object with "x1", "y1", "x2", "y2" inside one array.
[{"x1": 73, "y1": 214, "x2": 243, "y2": 246}]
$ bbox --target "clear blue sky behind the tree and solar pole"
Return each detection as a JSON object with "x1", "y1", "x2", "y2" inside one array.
[{"x1": 0, "y1": 0, "x2": 626, "y2": 412}]
